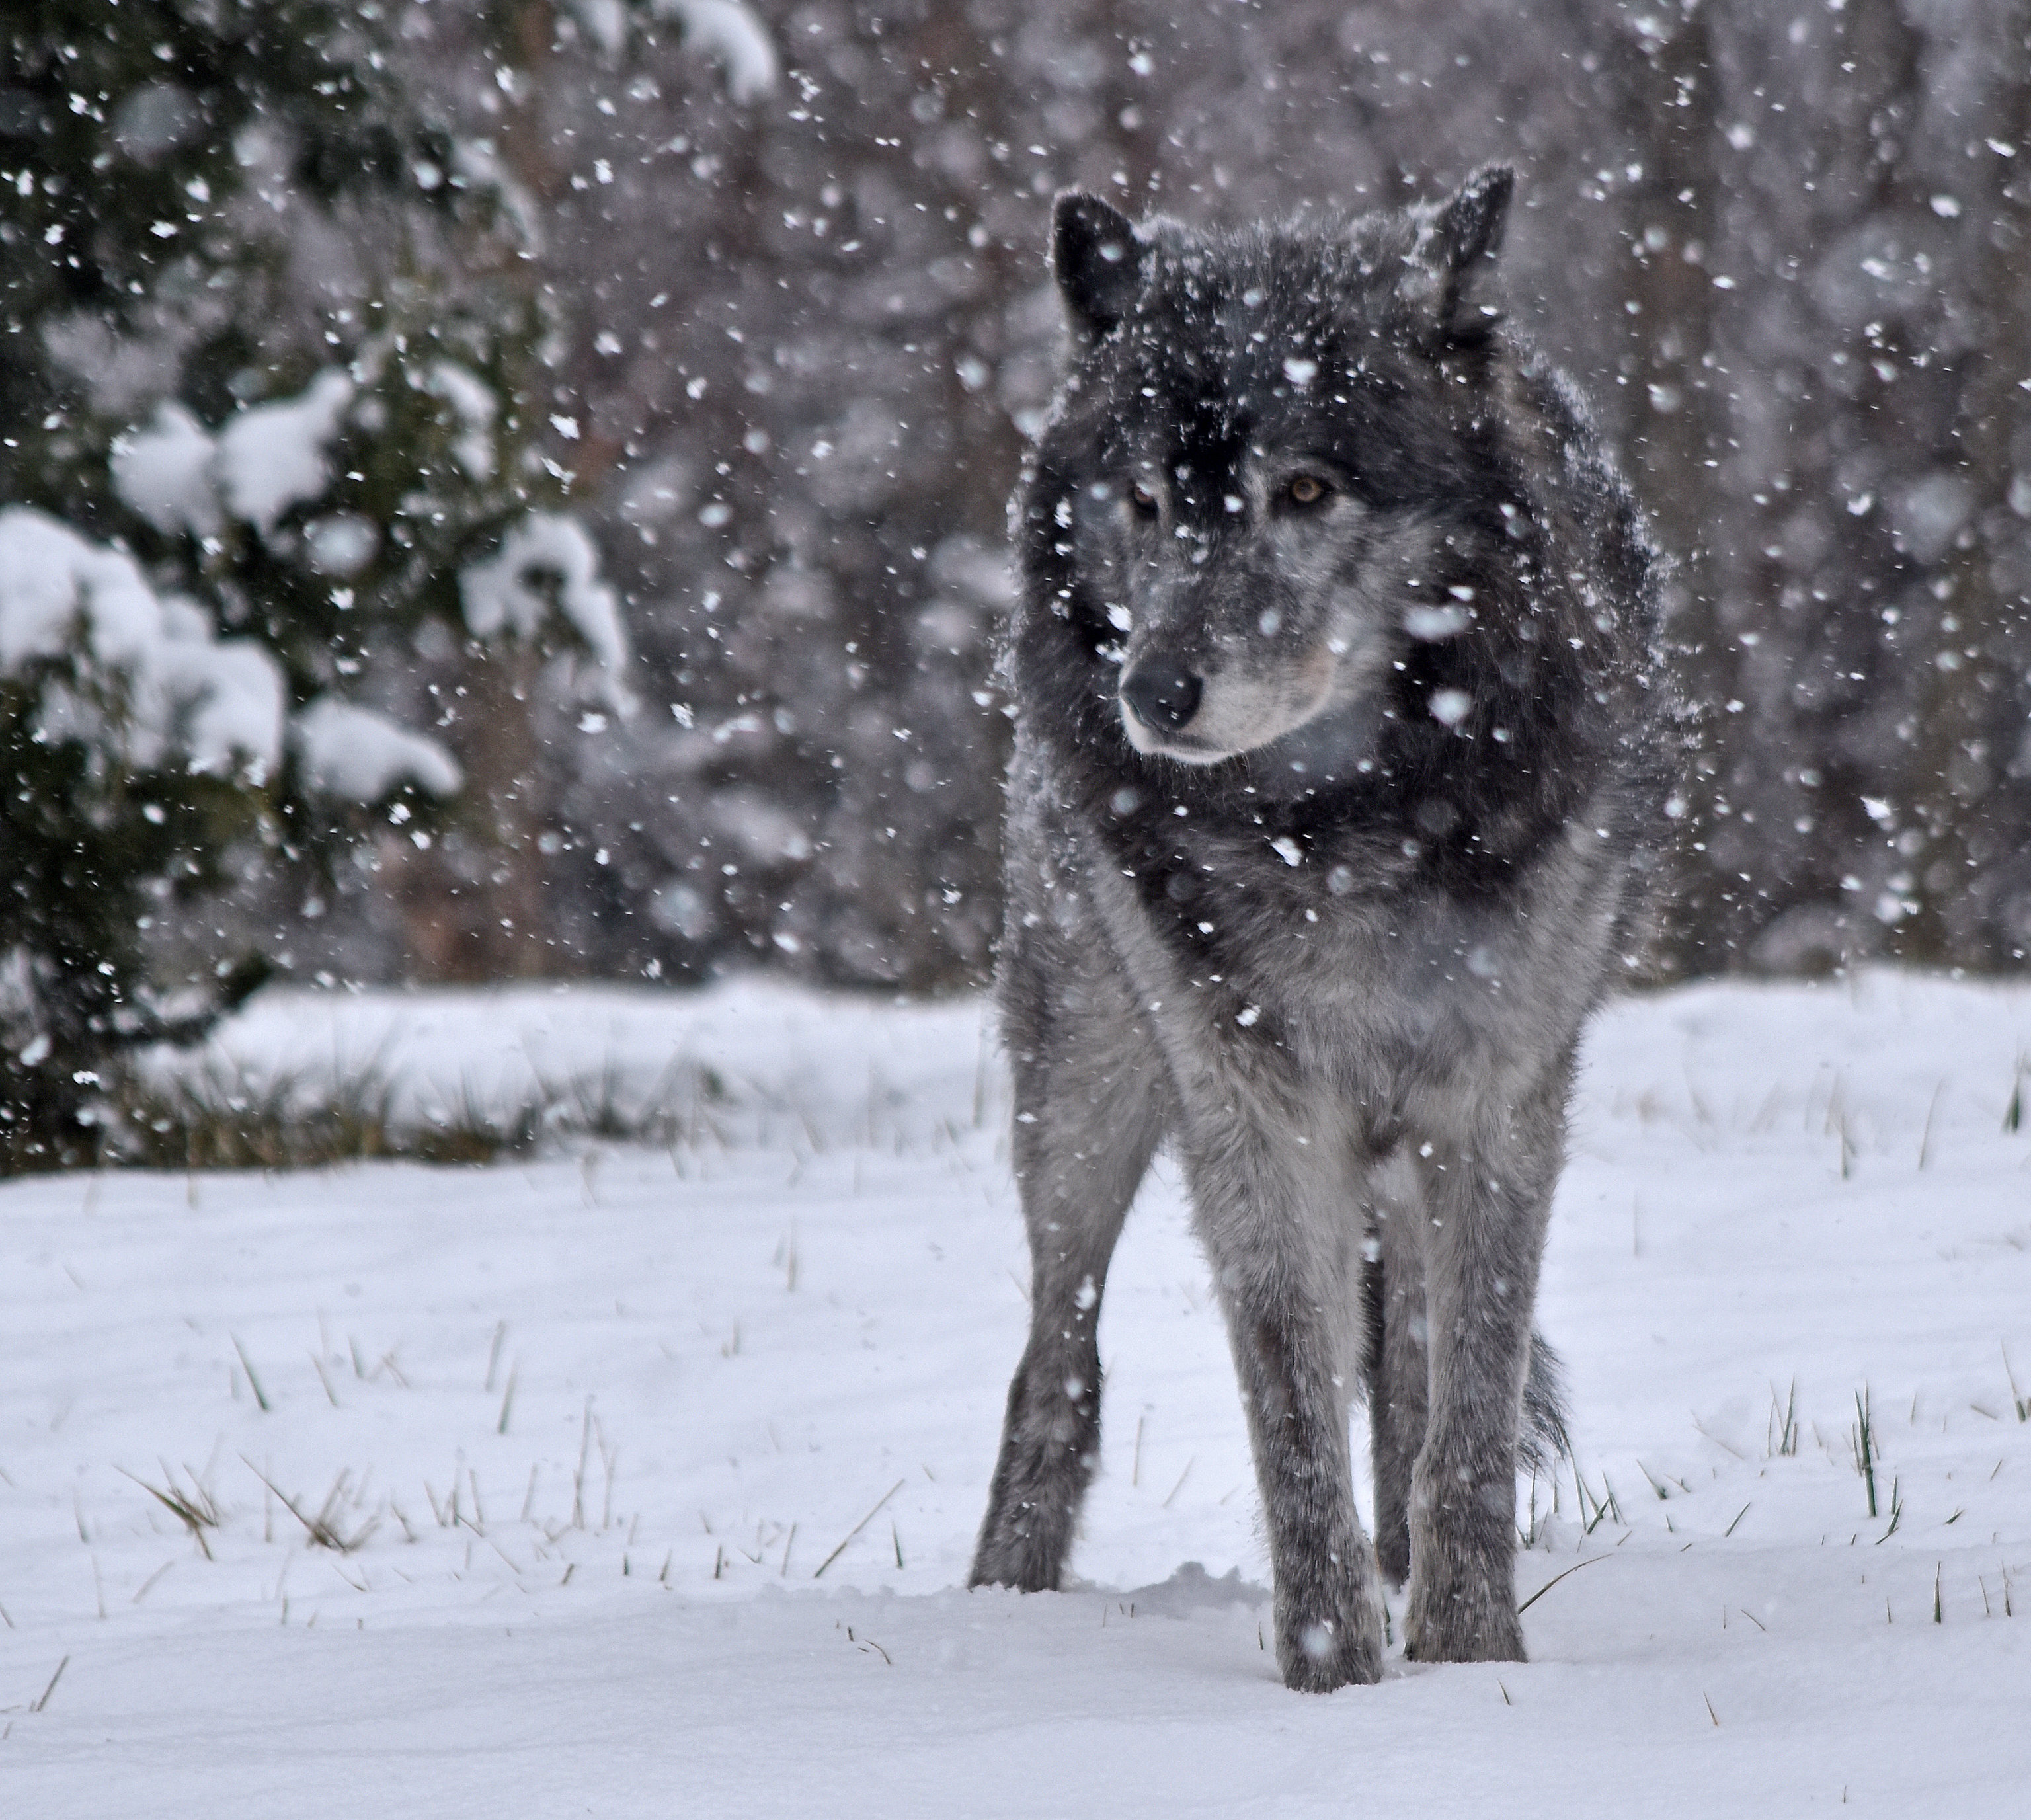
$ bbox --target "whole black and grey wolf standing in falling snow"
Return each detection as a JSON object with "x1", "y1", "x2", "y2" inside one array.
[{"x1": 971, "y1": 167, "x2": 1673, "y2": 1692}]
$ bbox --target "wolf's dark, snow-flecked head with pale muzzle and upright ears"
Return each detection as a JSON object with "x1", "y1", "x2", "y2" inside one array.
[{"x1": 1027, "y1": 167, "x2": 1513, "y2": 770}]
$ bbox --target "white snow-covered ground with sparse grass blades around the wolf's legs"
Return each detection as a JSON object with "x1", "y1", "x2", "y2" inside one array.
[{"x1": 0, "y1": 975, "x2": 2031, "y2": 1820}]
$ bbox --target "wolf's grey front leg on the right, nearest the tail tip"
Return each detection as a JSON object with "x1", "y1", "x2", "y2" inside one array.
[{"x1": 1404, "y1": 1097, "x2": 1562, "y2": 1661}]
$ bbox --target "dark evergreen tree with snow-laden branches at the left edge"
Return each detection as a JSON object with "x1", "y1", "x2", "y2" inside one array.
[{"x1": 0, "y1": 0, "x2": 621, "y2": 1172}]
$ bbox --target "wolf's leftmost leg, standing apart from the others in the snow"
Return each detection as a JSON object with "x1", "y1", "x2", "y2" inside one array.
[{"x1": 969, "y1": 979, "x2": 1164, "y2": 1593}]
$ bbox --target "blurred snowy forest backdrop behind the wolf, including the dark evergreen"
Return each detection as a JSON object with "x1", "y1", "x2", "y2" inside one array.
[{"x1": 0, "y1": 0, "x2": 2031, "y2": 1162}]
